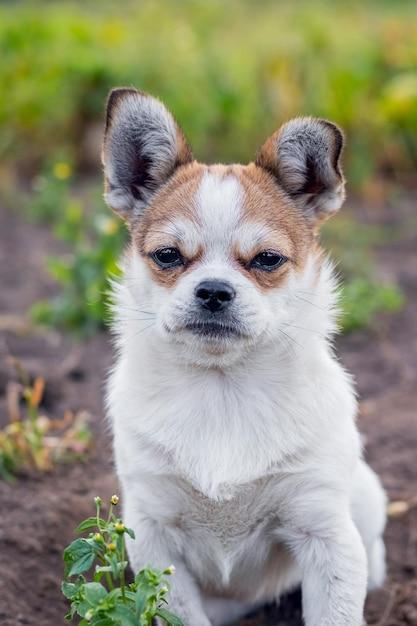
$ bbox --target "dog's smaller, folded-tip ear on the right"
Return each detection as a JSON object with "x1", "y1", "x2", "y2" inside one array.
[{"x1": 256, "y1": 118, "x2": 345, "y2": 224}]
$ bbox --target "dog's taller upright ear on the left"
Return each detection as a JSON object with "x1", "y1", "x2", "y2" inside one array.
[{"x1": 102, "y1": 88, "x2": 193, "y2": 221}]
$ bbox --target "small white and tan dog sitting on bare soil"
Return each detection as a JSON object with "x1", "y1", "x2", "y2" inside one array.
[{"x1": 102, "y1": 88, "x2": 386, "y2": 626}]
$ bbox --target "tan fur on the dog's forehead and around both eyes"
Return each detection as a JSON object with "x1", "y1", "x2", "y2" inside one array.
[{"x1": 132, "y1": 162, "x2": 314, "y2": 290}]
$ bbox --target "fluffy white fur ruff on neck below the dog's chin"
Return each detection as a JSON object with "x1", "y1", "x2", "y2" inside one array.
[{"x1": 109, "y1": 252, "x2": 353, "y2": 498}]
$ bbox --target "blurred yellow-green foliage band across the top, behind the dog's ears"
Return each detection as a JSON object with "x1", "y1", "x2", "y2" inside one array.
[{"x1": 0, "y1": 0, "x2": 417, "y2": 189}]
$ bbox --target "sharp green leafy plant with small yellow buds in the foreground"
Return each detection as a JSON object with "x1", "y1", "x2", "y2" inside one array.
[{"x1": 62, "y1": 496, "x2": 183, "y2": 626}]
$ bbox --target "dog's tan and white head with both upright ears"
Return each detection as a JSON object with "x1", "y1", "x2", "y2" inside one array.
[{"x1": 103, "y1": 89, "x2": 344, "y2": 363}]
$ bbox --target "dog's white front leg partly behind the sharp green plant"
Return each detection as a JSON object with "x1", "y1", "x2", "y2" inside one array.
[{"x1": 125, "y1": 507, "x2": 210, "y2": 626}]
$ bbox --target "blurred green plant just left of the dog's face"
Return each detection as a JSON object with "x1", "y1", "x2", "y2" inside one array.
[{"x1": 31, "y1": 163, "x2": 125, "y2": 335}]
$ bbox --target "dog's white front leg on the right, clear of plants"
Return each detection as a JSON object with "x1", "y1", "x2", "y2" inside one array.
[{"x1": 279, "y1": 492, "x2": 367, "y2": 626}]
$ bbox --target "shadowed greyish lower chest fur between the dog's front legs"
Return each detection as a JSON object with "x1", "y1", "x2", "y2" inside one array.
[{"x1": 169, "y1": 476, "x2": 288, "y2": 597}]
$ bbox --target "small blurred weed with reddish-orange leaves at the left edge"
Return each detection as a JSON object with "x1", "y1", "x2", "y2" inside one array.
[{"x1": 0, "y1": 359, "x2": 91, "y2": 481}]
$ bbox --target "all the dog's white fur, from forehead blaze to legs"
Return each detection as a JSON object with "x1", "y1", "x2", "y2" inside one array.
[{"x1": 108, "y1": 169, "x2": 385, "y2": 626}]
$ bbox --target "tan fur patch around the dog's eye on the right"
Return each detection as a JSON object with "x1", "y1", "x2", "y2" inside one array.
[{"x1": 234, "y1": 163, "x2": 314, "y2": 289}]
